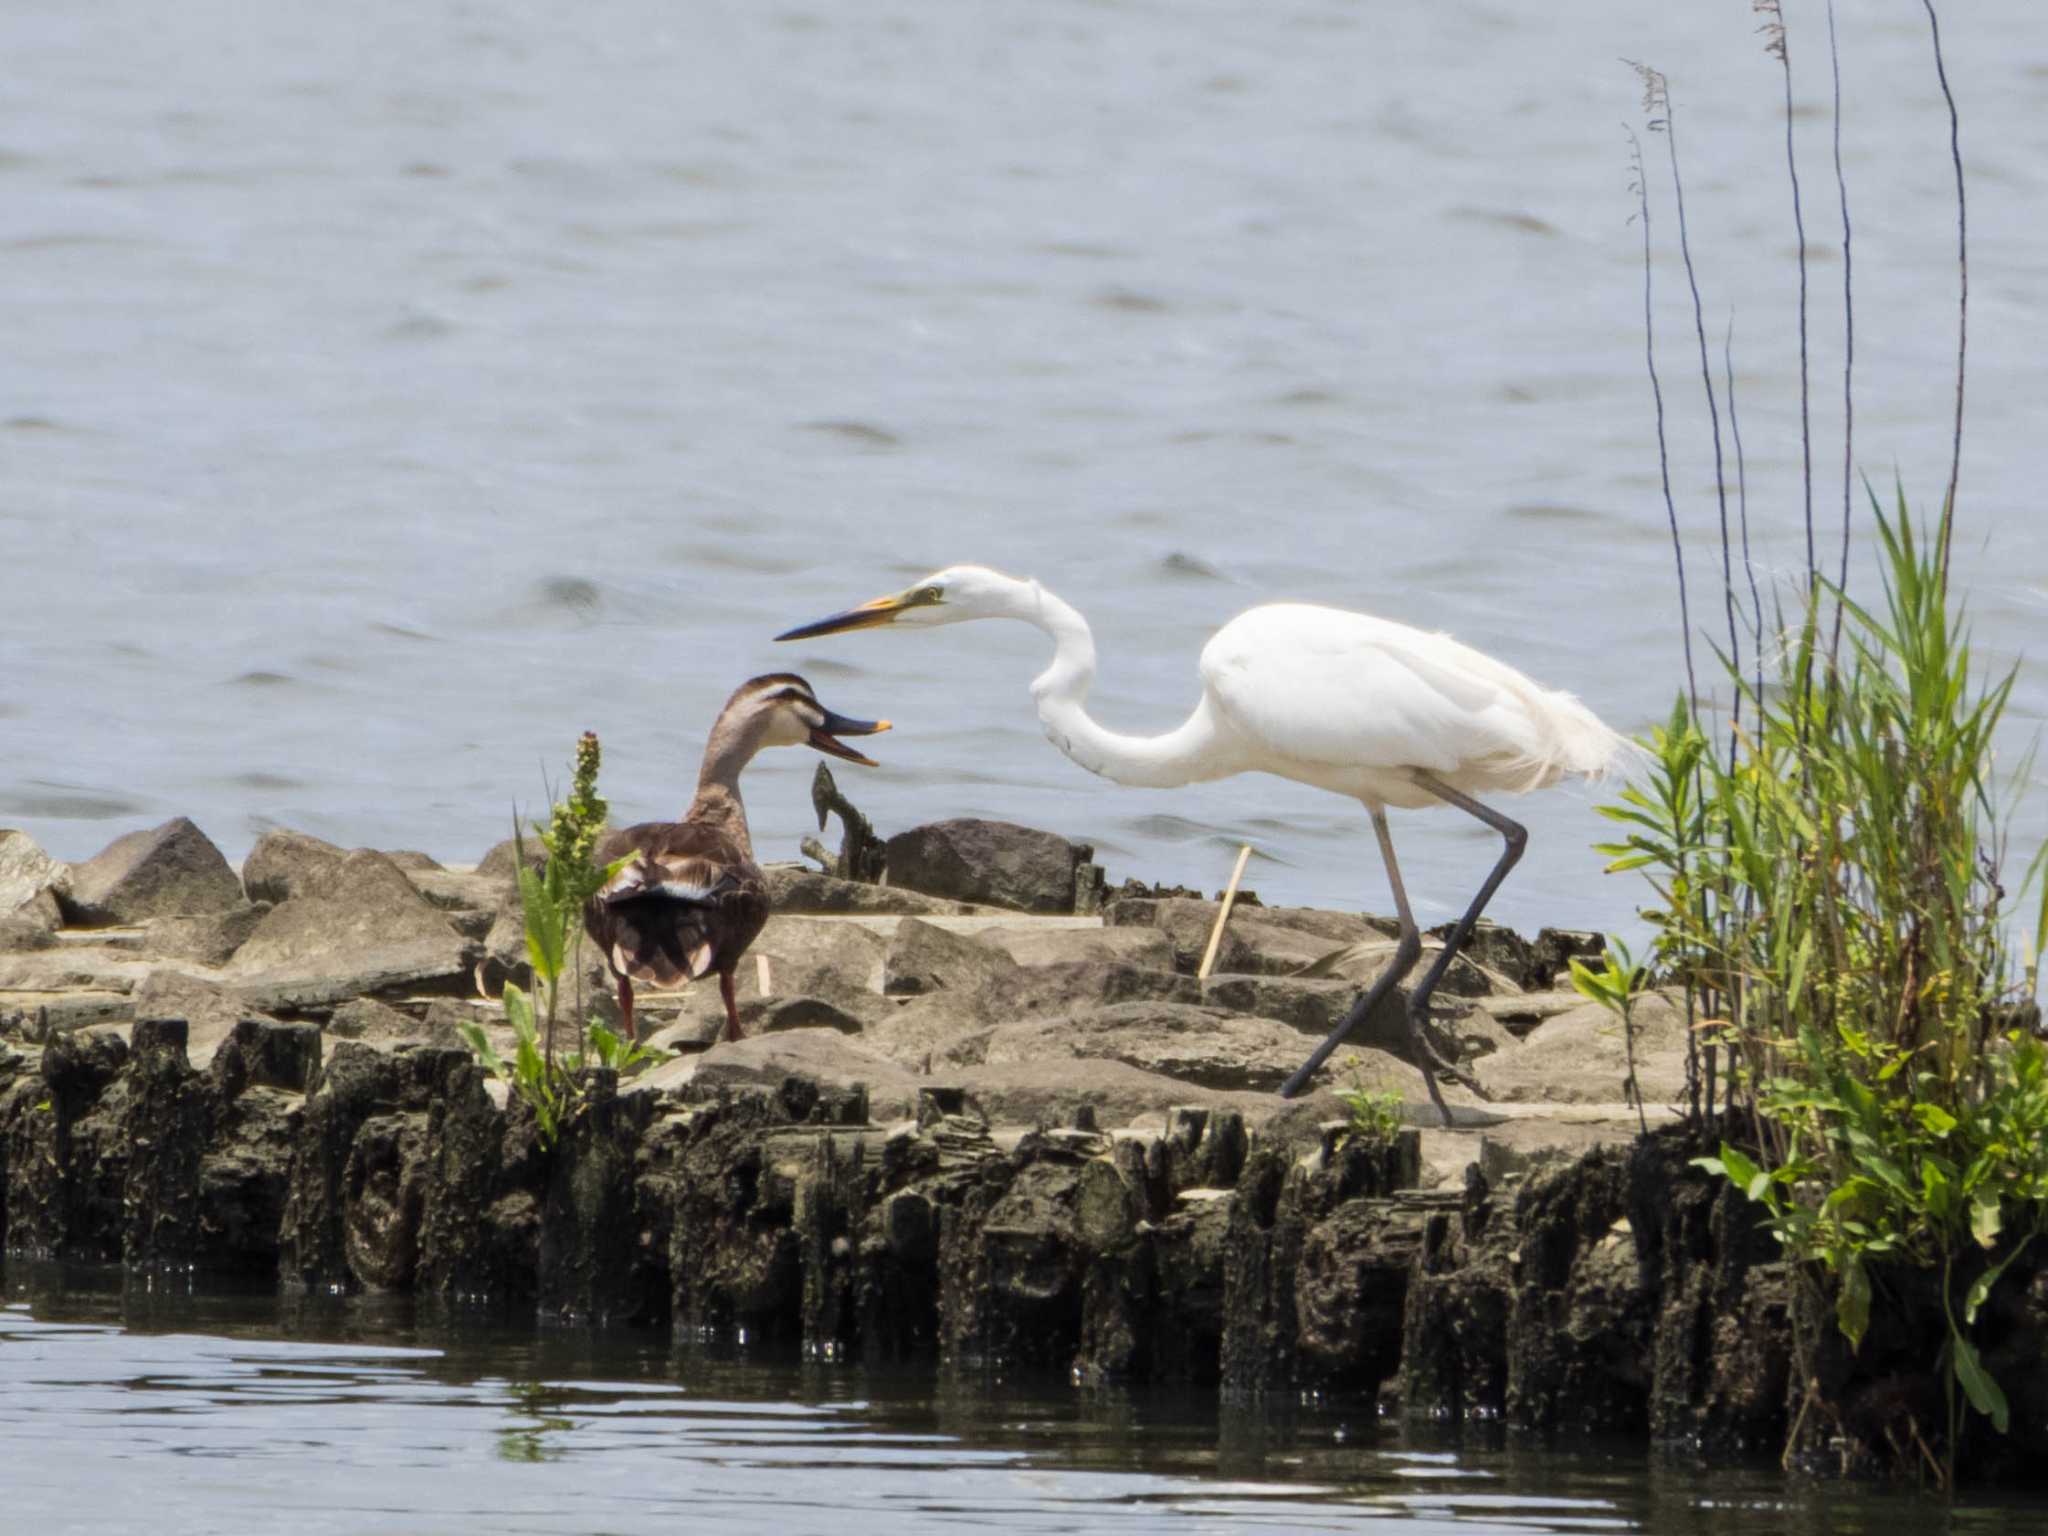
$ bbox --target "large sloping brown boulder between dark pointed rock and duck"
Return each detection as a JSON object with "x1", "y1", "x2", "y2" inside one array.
[{"x1": 229, "y1": 850, "x2": 467, "y2": 1008}]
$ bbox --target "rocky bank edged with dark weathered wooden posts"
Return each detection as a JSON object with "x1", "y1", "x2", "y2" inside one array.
[{"x1": 0, "y1": 821, "x2": 2048, "y2": 1464}]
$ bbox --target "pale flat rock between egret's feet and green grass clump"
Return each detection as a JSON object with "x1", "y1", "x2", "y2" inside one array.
[{"x1": 1473, "y1": 993, "x2": 1686, "y2": 1106}]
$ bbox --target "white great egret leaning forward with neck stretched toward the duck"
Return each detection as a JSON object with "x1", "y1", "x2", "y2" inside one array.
[{"x1": 776, "y1": 565, "x2": 1626, "y2": 1124}]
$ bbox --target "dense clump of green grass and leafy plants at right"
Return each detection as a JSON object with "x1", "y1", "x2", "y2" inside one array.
[{"x1": 1602, "y1": 496, "x2": 2048, "y2": 1475}]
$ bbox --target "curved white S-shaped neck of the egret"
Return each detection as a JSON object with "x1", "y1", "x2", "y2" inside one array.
[{"x1": 1014, "y1": 582, "x2": 1231, "y2": 788}]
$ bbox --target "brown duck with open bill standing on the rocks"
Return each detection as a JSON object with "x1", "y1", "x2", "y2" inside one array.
[{"x1": 584, "y1": 672, "x2": 889, "y2": 1040}]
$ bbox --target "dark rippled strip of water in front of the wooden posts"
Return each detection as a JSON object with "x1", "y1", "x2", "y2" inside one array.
[{"x1": 0, "y1": 1266, "x2": 2048, "y2": 1536}]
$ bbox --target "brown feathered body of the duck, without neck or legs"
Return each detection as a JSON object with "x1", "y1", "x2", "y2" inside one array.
[{"x1": 584, "y1": 821, "x2": 768, "y2": 987}]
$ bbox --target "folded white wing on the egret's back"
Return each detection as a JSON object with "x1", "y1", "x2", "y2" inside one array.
[{"x1": 1202, "y1": 604, "x2": 1536, "y2": 774}]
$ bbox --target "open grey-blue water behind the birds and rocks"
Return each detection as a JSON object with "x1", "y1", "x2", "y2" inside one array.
[{"x1": 0, "y1": 0, "x2": 2048, "y2": 924}]
